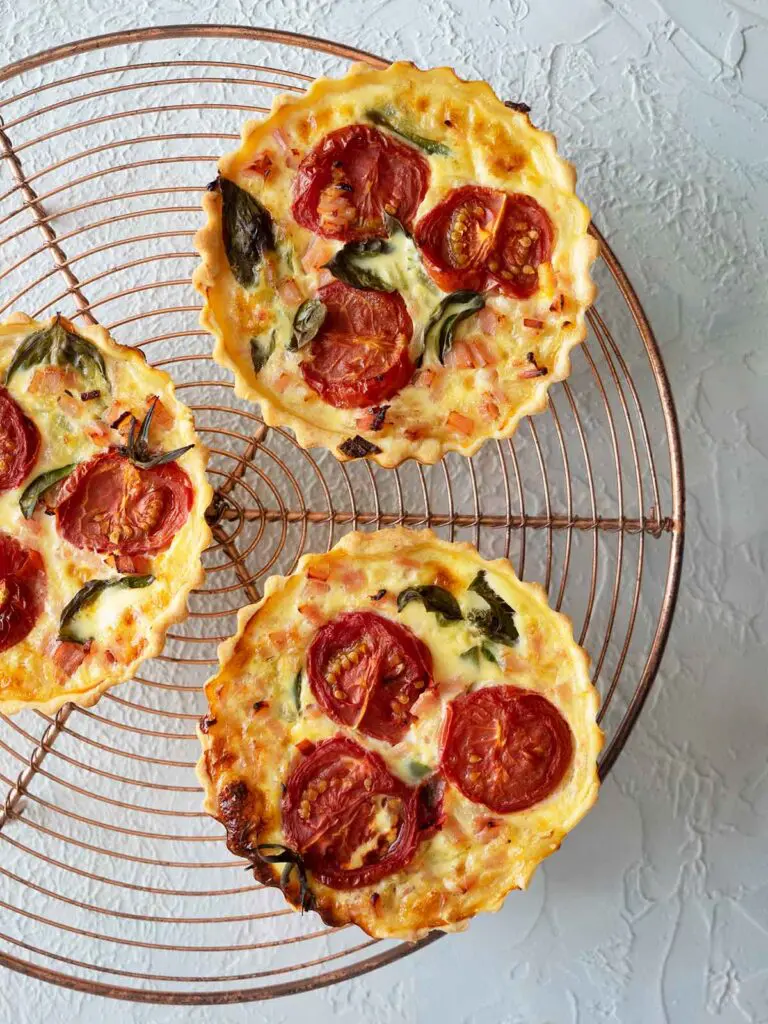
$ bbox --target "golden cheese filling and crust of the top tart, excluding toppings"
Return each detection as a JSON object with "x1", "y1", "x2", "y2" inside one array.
[{"x1": 195, "y1": 63, "x2": 597, "y2": 466}]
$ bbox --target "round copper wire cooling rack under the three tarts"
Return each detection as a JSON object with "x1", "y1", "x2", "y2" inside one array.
[{"x1": 0, "y1": 26, "x2": 684, "y2": 1004}]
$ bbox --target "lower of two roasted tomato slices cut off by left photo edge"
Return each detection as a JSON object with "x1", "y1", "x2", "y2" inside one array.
[{"x1": 0, "y1": 534, "x2": 46, "y2": 651}]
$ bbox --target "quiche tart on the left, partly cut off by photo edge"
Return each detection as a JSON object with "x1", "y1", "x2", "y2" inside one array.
[{"x1": 0, "y1": 313, "x2": 211, "y2": 714}]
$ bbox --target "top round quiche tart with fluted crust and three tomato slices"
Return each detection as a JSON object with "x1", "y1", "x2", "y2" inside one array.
[{"x1": 194, "y1": 63, "x2": 597, "y2": 467}]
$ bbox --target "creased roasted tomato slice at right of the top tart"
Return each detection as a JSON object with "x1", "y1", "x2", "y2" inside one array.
[{"x1": 415, "y1": 185, "x2": 554, "y2": 299}]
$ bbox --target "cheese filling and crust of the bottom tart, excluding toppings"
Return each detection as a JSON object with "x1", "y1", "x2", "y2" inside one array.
[{"x1": 200, "y1": 529, "x2": 602, "y2": 938}]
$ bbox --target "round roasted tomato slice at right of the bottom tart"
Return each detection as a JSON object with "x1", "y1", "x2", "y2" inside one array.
[{"x1": 440, "y1": 686, "x2": 573, "y2": 814}]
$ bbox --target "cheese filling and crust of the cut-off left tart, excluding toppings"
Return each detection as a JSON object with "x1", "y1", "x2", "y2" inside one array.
[{"x1": 0, "y1": 313, "x2": 211, "y2": 714}]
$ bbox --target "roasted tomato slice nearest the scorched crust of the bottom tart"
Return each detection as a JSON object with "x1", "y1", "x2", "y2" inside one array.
[{"x1": 283, "y1": 736, "x2": 425, "y2": 889}]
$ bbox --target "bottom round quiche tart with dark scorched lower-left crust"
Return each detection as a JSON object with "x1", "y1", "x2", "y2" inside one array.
[{"x1": 198, "y1": 528, "x2": 602, "y2": 939}]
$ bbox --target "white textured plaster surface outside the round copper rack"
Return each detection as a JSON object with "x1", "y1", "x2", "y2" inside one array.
[{"x1": 0, "y1": 0, "x2": 768, "y2": 1024}]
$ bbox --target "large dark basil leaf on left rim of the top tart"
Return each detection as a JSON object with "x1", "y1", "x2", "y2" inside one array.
[{"x1": 218, "y1": 176, "x2": 274, "y2": 288}]
